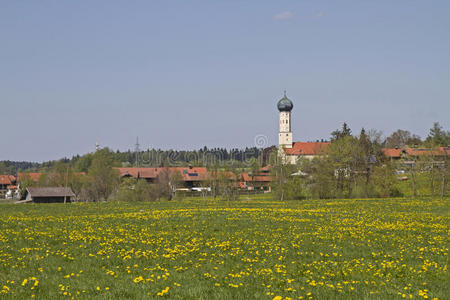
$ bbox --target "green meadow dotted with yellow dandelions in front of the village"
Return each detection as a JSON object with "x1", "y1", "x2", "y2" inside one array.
[{"x1": 0, "y1": 199, "x2": 450, "y2": 299}]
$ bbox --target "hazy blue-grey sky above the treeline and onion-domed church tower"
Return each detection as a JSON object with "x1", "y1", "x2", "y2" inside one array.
[{"x1": 0, "y1": 0, "x2": 450, "y2": 161}]
